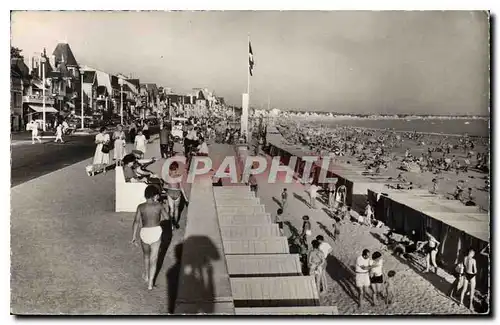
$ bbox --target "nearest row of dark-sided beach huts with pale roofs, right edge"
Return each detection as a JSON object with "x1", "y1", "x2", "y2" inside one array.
[{"x1": 368, "y1": 188, "x2": 490, "y2": 291}]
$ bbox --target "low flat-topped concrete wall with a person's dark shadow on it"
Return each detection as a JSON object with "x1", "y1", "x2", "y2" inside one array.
[{"x1": 175, "y1": 179, "x2": 234, "y2": 314}]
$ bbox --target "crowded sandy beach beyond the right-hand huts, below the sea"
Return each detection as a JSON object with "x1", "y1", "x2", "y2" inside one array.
[{"x1": 278, "y1": 117, "x2": 490, "y2": 211}]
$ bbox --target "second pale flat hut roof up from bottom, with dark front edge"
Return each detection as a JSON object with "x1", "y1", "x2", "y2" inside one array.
[{"x1": 231, "y1": 276, "x2": 319, "y2": 308}]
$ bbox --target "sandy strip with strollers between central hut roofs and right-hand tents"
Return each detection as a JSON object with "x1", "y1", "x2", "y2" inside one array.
[{"x1": 250, "y1": 146, "x2": 476, "y2": 315}]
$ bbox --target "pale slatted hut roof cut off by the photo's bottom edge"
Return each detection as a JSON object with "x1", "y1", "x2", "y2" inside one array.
[{"x1": 234, "y1": 306, "x2": 339, "y2": 316}]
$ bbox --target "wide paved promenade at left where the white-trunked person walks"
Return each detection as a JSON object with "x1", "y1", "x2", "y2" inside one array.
[{"x1": 11, "y1": 141, "x2": 185, "y2": 314}]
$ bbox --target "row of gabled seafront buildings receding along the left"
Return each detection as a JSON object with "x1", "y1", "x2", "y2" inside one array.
[{"x1": 11, "y1": 43, "x2": 225, "y2": 131}]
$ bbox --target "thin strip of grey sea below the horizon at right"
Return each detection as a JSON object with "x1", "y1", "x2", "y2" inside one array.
[{"x1": 321, "y1": 119, "x2": 490, "y2": 137}]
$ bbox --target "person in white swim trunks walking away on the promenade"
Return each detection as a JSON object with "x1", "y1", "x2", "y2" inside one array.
[{"x1": 131, "y1": 185, "x2": 168, "y2": 290}]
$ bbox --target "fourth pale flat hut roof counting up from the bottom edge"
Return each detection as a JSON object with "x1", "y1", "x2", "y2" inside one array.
[{"x1": 222, "y1": 237, "x2": 290, "y2": 255}]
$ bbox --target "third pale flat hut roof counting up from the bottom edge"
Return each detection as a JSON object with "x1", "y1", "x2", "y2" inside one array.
[{"x1": 226, "y1": 254, "x2": 302, "y2": 277}]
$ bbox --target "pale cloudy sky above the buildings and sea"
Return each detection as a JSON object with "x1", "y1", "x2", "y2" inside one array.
[{"x1": 11, "y1": 11, "x2": 490, "y2": 115}]
